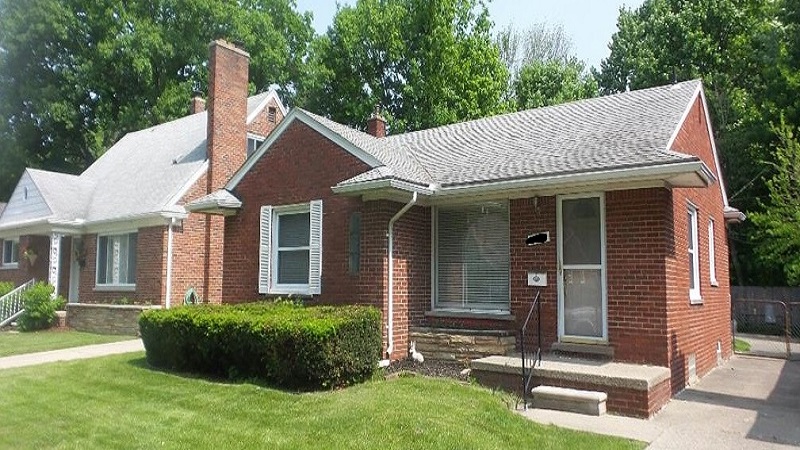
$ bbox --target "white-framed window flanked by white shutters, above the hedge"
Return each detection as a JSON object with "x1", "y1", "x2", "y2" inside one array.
[{"x1": 259, "y1": 200, "x2": 322, "y2": 295}]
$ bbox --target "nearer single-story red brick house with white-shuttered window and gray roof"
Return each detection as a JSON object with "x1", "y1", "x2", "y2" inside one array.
[{"x1": 187, "y1": 50, "x2": 744, "y2": 415}]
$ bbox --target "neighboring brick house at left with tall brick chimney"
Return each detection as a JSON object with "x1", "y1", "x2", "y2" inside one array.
[{"x1": 0, "y1": 41, "x2": 286, "y2": 306}]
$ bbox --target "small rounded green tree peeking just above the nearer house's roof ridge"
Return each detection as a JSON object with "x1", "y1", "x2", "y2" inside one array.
[{"x1": 514, "y1": 59, "x2": 598, "y2": 110}]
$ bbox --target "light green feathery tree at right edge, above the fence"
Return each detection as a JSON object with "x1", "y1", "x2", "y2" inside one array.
[{"x1": 750, "y1": 121, "x2": 800, "y2": 286}]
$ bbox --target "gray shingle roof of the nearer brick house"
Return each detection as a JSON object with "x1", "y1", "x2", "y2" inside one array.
[{"x1": 332, "y1": 80, "x2": 700, "y2": 187}]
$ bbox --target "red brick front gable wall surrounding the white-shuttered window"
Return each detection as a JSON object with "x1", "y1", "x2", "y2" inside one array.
[{"x1": 222, "y1": 122, "x2": 369, "y2": 303}]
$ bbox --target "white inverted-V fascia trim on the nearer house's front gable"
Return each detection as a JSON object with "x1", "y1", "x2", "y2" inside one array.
[{"x1": 225, "y1": 108, "x2": 383, "y2": 192}]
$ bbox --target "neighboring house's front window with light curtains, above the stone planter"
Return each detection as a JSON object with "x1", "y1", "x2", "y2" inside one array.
[{"x1": 97, "y1": 233, "x2": 137, "y2": 286}]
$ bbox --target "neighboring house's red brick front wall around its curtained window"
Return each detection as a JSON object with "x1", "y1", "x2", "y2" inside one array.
[{"x1": 78, "y1": 227, "x2": 166, "y2": 304}]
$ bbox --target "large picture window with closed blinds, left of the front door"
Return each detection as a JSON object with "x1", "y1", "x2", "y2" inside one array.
[{"x1": 434, "y1": 202, "x2": 510, "y2": 311}]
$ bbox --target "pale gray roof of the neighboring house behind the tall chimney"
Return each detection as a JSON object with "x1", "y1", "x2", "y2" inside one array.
[{"x1": 0, "y1": 91, "x2": 283, "y2": 234}]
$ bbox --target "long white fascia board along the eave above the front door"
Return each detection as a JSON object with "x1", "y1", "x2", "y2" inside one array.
[{"x1": 433, "y1": 160, "x2": 714, "y2": 197}]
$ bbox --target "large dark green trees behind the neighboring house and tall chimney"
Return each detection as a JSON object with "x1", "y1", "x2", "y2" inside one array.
[{"x1": 0, "y1": 0, "x2": 313, "y2": 198}]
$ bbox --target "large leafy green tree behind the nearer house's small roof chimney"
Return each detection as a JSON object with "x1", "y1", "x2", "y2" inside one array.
[{"x1": 298, "y1": 0, "x2": 508, "y2": 132}]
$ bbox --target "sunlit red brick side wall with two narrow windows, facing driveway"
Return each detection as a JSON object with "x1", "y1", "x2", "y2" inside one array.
[{"x1": 666, "y1": 99, "x2": 731, "y2": 392}]
